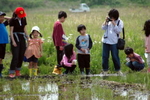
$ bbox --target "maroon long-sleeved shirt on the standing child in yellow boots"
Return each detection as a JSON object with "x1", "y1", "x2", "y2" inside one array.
[{"x1": 52, "y1": 21, "x2": 65, "y2": 46}]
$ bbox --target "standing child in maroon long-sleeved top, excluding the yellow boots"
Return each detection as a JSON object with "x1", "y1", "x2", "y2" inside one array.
[{"x1": 52, "y1": 11, "x2": 67, "y2": 65}]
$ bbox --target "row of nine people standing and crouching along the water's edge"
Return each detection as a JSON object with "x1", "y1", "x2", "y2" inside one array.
[{"x1": 0, "y1": 7, "x2": 150, "y2": 78}]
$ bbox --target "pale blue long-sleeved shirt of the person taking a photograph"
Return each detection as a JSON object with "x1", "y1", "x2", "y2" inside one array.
[{"x1": 102, "y1": 19, "x2": 123, "y2": 44}]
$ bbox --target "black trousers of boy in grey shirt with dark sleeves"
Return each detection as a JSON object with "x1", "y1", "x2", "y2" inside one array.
[{"x1": 77, "y1": 54, "x2": 90, "y2": 72}]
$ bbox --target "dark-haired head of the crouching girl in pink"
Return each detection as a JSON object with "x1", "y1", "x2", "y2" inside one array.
[{"x1": 64, "y1": 44, "x2": 73, "y2": 59}]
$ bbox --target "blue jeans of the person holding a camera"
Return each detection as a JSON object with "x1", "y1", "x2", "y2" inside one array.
[{"x1": 102, "y1": 43, "x2": 120, "y2": 71}]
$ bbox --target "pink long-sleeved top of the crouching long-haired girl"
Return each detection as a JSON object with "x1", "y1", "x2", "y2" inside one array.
[{"x1": 60, "y1": 52, "x2": 76, "y2": 67}]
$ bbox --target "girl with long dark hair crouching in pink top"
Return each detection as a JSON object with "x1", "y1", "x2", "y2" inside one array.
[{"x1": 60, "y1": 44, "x2": 76, "y2": 74}]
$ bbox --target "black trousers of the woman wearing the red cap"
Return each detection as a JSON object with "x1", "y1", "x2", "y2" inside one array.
[{"x1": 9, "y1": 35, "x2": 26, "y2": 73}]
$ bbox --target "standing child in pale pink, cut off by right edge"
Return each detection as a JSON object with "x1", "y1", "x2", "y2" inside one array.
[{"x1": 143, "y1": 20, "x2": 150, "y2": 72}]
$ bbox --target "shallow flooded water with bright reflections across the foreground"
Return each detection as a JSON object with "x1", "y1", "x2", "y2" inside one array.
[{"x1": 0, "y1": 77, "x2": 149, "y2": 100}]
